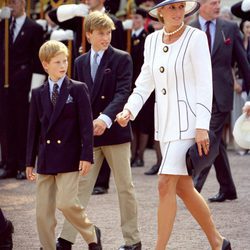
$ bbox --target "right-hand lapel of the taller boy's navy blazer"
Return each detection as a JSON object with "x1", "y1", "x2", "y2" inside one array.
[{"x1": 92, "y1": 46, "x2": 113, "y2": 103}]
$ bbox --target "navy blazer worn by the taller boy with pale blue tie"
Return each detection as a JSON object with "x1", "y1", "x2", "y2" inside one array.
[{"x1": 75, "y1": 46, "x2": 133, "y2": 147}]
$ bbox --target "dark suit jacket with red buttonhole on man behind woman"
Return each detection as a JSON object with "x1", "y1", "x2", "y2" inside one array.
[{"x1": 190, "y1": 18, "x2": 250, "y2": 112}]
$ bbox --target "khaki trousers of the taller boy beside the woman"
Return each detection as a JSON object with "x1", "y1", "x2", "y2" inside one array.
[{"x1": 60, "y1": 143, "x2": 140, "y2": 245}]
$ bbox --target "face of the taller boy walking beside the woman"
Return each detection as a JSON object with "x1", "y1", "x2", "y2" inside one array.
[{"x1": 86, "y1": 29, "x2": 112, "y2": 51}]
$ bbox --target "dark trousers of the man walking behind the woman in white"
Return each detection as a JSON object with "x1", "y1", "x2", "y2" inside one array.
[{"x1": 193, "y1": 103, "x2": 236, "y2": 194}]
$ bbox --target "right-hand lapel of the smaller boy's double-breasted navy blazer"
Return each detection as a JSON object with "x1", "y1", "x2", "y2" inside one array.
[{"x1": 48, "y1": 76, "x2": 70, "y2": 130}]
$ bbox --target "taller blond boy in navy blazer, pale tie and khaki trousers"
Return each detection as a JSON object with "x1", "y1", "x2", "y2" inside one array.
[{"x1": 58, "y1": 11, "x2": 141, "y2": 250}]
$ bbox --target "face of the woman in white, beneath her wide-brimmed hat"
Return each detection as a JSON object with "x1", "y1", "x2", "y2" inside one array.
[{"x1": 159, "y1": 2, "x2": 186, "y2": 26}]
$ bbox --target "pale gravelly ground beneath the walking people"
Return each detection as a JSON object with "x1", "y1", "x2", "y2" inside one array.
[{"x1": 0, "y1": 150, "x2": 250, "y2": 250}]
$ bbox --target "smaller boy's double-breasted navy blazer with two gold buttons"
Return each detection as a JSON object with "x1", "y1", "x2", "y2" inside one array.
[{"x1": 26, "y1": 76, "x2": 93, "y2": 174}]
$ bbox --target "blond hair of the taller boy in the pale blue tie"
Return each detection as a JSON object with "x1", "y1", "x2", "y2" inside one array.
[{"x1": 84, "y1": 11, "x2": 115, "y2": 32}]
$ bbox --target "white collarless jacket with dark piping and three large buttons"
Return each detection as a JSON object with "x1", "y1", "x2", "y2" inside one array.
[{"x1": 124, "y1": 26, "x2": 212, "y2": 142}]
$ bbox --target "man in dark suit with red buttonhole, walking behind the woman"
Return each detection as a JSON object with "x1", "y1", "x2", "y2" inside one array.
[{"x1": 191, "y1": 0, "x2": 250, "y2": 202}]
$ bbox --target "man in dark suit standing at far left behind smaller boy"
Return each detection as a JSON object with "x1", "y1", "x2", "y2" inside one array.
[{"x1": 0, "y1": 0, "x2": 45, "y2": 179}]
